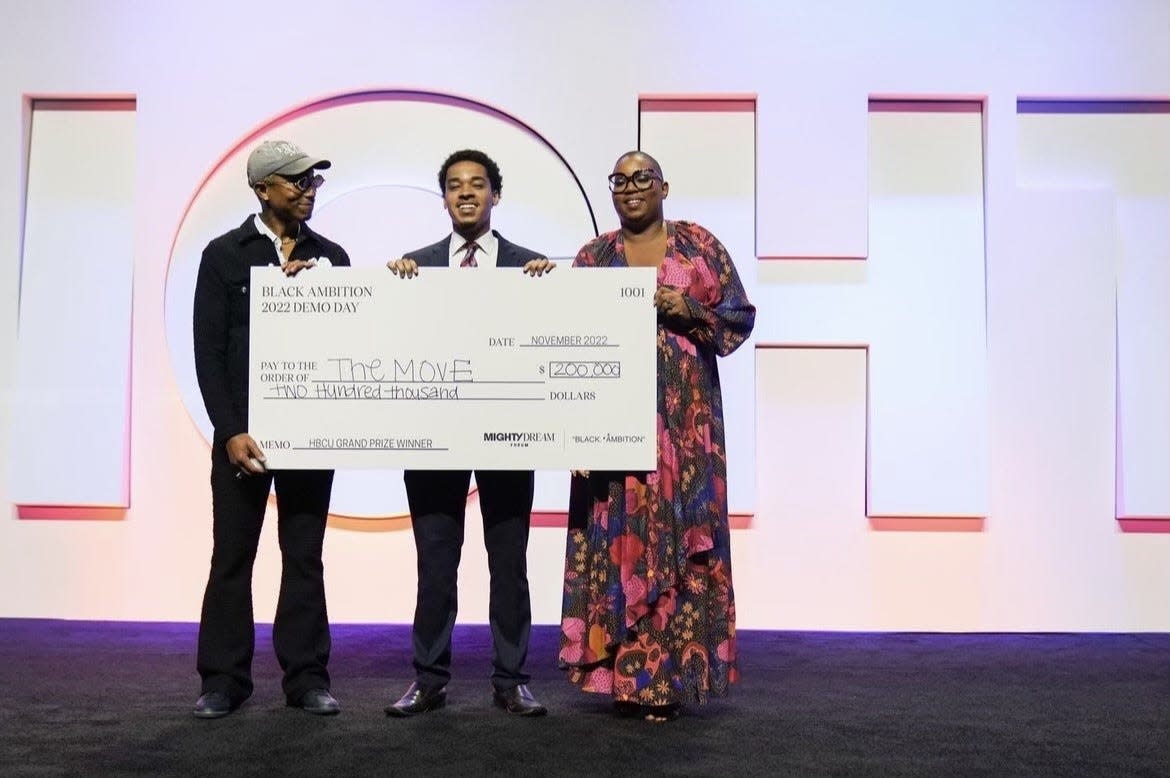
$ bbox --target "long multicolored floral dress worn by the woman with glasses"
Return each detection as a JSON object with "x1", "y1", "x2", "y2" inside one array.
[{"x1": 559, "y1": 221, "x2": 756, "y2": 705}]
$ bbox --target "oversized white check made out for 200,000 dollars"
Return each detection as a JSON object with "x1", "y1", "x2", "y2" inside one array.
[{"x1": 248, "y1": 266, "x2": 656, "y2": 470}]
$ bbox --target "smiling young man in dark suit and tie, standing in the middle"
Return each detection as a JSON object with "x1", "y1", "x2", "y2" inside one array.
[{"x1": 386, "y1": 150, "x2": 556, "y2": 717}]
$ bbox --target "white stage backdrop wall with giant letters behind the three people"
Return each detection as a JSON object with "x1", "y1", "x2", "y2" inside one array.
[{"x1": 0, "y1": 0, "x2": 1170, "y2": 631}]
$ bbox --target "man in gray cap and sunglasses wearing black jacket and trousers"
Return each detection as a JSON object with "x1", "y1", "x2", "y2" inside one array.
[{"x1": 194, "y1": 140, "x2": 350, "y2": 718}]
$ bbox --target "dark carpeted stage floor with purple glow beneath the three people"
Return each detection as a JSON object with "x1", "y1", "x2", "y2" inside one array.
[{"x1": 0, "y1": 619, "x2": 1170, "y2": 778}]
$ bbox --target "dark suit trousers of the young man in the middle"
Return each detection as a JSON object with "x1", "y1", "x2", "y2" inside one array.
[{"x1": 405, "y1": 470, "x2": 532, "y2": 690}]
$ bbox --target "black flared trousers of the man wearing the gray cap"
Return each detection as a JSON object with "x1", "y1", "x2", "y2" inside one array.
[{"x1": 197, "y1": 443, "x2": 333, "y2": 703}]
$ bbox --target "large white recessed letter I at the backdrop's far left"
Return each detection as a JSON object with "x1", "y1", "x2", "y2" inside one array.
[{"x1": 8, "y1": 99, "x2": 137, "y2": 518}]
